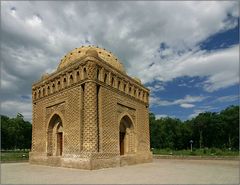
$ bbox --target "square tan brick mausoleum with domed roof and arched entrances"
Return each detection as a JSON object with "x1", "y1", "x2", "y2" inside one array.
[{"x1": 30, "y1": 46, "x2": 152, "y2": 169}]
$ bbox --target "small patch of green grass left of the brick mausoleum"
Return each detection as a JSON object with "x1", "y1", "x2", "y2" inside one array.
[{"x1": 1, "y1": 151, "x2": 29, "y2": 162}]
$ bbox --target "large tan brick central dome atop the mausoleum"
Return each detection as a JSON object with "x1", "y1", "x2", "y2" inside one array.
[{"x1": 58, "y1": 46, "x2": 126, "y2": 73}]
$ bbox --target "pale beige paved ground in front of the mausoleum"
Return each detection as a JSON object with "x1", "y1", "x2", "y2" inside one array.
[{"x1": 1, "y1": 159, "x2": 239, "y2": 184}]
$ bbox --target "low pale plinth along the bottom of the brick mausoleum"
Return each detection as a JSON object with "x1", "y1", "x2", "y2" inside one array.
[{"x1": 29, "y1": 152, "x2": 152, "y2": 170}]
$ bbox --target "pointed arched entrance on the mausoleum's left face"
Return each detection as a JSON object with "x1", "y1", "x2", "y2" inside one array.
[{"x1": 47, "y1": 114, "x2": 63, "y2": 156}]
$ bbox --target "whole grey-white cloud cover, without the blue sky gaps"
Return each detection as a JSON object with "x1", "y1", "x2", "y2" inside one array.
[{"x1": 1, "y1": 1, "x2": 238, "y2": 118}]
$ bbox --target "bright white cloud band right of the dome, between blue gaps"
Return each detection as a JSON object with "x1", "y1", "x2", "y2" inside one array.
[{"x1": 136, "y1": 45, "x2": 239, "y2": 92}]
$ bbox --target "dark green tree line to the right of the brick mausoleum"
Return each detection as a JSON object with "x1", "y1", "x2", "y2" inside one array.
[{"x1": 149, "y1": 106, "x2": 239, "y2": 150}]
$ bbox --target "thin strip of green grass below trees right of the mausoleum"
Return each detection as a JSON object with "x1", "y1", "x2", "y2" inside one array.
[{"x1": 152, "y1": 148, "x2": 239, "y2": 156}]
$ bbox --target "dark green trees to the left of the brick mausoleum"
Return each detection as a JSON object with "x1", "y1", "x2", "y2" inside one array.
[{"x1": 1, "y1": 113, "x2": 32, "y2": 150}]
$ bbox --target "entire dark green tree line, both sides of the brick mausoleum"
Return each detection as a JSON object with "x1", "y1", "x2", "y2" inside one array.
[{"x1": 1, "y1": 106, "x2": 239, "y2": 150}]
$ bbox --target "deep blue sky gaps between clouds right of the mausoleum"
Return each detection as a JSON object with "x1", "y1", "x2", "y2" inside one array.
[{"x1": 149, "y1": 24, "x2": 239, "y2": 120}]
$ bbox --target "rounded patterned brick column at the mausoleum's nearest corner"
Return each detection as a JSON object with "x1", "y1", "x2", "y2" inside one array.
[{"x1": 83, "y1": 61, "x2": 98, "y2": 152}]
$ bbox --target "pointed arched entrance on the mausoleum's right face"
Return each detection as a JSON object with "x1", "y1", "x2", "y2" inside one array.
[{"x1": 119, "y1": 115, "x2": 135, "y2": 155}]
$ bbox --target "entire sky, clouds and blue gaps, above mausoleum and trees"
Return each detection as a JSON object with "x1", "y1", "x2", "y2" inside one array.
[{"x1": 1, "y1": 1, "x2": 239, "y2": 121}]
